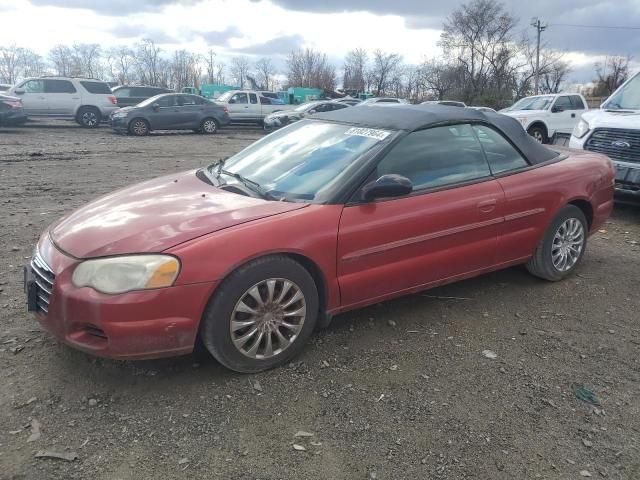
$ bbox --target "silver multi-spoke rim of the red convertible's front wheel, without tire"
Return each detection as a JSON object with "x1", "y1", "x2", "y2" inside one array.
[{"x1": 229, "y1": 278, "x2": 307, "y2": 360}]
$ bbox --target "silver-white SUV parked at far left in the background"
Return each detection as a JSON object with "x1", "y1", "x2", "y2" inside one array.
[{"x1": 7, "y1": 77, "x2": 118, "y2": 128}]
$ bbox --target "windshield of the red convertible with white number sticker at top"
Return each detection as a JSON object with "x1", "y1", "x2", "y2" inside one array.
[{"x1": 209, "y1": 120, "x2": 396, "y2": 203}]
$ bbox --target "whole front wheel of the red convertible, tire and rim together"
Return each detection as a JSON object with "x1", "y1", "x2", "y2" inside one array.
[{"x1": 200, "y1": 255, "x2": 318, "y2": 373}]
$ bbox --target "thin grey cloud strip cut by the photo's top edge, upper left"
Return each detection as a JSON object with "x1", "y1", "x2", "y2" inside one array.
[{"x1": 31, "y1": 0, "x2": 202, "y2": 17}]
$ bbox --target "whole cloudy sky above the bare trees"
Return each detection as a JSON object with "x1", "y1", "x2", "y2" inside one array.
[{"x1": 0, "y1": 0, "x2": 640, "y2": 82}]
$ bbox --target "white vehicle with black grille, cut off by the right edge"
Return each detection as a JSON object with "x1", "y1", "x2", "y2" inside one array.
[{"x1": 569, "y1": 73, "x2": 640, "y2": 199}]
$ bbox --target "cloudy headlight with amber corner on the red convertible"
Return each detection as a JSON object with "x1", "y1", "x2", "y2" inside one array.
[{"x1": 71, "y1": 255, "x2": 180, "y2": 294}]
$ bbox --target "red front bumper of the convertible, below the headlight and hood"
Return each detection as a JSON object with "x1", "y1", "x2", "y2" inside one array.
[{"x1": 25, "y1": 236, "x2": 216, "y2": 359}]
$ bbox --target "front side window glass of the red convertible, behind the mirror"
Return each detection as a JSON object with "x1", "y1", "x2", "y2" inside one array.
[{"x1": 377, "y1": 125, "x2": 491, "y2": 192}]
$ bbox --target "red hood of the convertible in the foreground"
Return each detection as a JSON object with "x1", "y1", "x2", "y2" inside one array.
[{"x1": 50, "y1": 170, "x2": 305, "y2": 258}]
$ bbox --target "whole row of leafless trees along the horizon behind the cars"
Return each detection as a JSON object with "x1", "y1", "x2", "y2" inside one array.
[{"x1": 0, "y1": 0, "x2": 631, "y2": 107}]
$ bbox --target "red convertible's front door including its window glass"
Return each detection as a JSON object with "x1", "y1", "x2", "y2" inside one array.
[{"x1": 337, "y1": 125, "x2": 504, "y2": 307}]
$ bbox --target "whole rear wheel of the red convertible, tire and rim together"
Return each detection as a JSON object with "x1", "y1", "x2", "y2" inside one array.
[{"x1": 526, "y1": 205, "x2": 588, "y2": 282}]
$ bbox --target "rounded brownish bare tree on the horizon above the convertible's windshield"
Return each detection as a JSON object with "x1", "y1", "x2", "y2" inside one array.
[{"x1": 287, "y1": 48, "x2": 336, "y2": 91}]
